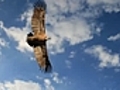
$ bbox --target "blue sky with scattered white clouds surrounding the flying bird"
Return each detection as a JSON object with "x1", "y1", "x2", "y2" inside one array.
[{"x1": 0, "y1": 0, "x2": 120, "y2": 90}]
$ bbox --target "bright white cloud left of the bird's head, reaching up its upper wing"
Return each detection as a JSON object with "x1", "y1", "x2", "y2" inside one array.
[{"x1": 0, "y1": 8, "x2": 33, "y2": 53}]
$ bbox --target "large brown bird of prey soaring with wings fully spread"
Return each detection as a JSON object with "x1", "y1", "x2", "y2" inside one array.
[{"x1": 27, "y1": 2, "x2": 52, "y2": 72}]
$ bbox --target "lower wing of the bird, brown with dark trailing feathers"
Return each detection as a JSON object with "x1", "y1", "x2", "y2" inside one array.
[{"x1": 34, "y1": 45, "x2": 52, "y2": 72}]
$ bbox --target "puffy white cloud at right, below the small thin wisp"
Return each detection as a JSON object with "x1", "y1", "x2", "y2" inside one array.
[{"x1": 85, "y1": 45, "x2": 120, "y2": 68}]
